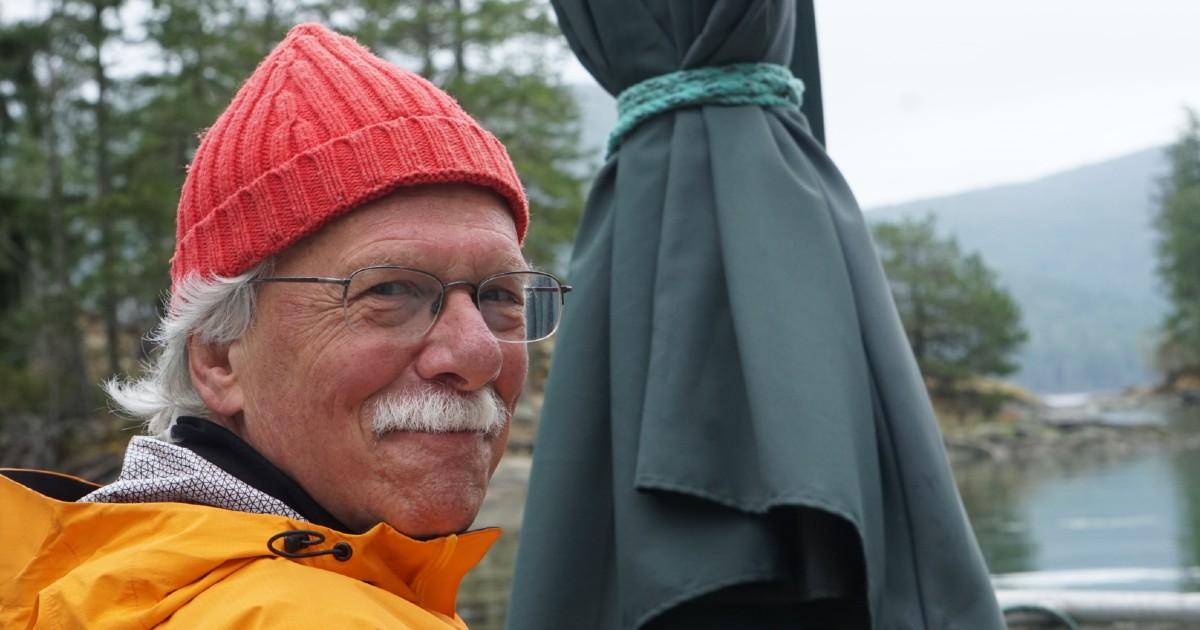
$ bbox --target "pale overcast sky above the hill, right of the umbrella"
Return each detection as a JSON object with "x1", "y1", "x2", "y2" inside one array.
[{"x1": 816, "y1": 0, "x2": 1200, "y2": 206}]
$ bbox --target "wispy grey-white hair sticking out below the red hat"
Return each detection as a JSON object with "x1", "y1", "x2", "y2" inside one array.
[{"x1": 104, "y1": 259, "x2": 272, "y2": 434}]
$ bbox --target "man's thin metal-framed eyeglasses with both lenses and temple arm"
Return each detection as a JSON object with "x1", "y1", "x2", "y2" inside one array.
[{"x1": 251, "y1": 265, "x2": 571, "y2": 343}]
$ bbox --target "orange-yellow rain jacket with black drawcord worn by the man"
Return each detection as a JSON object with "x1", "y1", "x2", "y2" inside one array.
[{"x1": 0, "y1": 473, "x2": 499, "y2": 630}]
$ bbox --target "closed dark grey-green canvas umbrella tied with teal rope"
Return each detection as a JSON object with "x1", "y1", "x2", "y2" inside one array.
[{"x1": 509, "y1": 0, "x2": 1003, "y2": 630}]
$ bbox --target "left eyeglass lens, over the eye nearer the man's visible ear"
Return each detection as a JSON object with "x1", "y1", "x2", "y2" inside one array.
[{"x1": 344, "y1": 268, "x2": 442, "y2": 337}]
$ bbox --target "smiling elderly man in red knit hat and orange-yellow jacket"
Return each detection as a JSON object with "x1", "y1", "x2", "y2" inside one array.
[{"x1": 0, "y1": 25, "x2": 565, "y2": 628}]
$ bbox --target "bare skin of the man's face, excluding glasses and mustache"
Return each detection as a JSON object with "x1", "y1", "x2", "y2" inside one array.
[{"x1": 229, "y1": 185, "x2": 528, "y2": 538}]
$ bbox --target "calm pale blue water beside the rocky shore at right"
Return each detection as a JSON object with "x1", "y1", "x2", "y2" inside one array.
[{"x1": 956, "y1": 409, "x2": 1200, "y2": 590}]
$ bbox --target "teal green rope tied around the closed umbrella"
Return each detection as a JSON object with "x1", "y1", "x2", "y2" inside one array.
[{"x1": 605, "y1": 64, "x2": 804, "y2": 158}]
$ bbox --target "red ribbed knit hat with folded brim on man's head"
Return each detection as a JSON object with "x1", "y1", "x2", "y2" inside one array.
[{"x1": 170, "y1": 24, "x2": 529, "y2": 283}]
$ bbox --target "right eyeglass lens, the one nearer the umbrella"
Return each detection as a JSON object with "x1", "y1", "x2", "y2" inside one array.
[{"x1": 479, "y1": 271, "x2": 563, "y2": 343}]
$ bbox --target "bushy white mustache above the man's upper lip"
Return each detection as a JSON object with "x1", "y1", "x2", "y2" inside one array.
[{"x1": 371, "y1": 386, "x2": 509, "y2": 437}]
